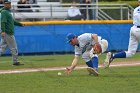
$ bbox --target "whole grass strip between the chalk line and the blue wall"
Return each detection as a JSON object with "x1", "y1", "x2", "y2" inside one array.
[{"x1": 0, "y1": 53, "x2": 140, "y2": 70}]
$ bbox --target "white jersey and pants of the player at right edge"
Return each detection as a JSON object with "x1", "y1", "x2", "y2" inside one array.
[{"x1": 126, "y1": 6, "x2": 140, "y2": 57}]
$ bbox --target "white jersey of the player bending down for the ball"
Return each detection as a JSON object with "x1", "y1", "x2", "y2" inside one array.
[{"x1": 75, "y1": 33, "x2": 101, "y2": 56}]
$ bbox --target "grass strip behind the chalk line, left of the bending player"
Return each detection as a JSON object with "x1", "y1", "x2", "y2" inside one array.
[{"x1": 0, "y1": 55, "x2": 83, "y2": 69}]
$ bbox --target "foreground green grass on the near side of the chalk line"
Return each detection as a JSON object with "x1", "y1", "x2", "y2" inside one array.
[{"x1": 0, "y1": 67, "x2": 140, "y2": 93}]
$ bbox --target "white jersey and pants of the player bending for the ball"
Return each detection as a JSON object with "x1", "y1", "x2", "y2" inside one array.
[{"x1": 75, "y1": 33, "x2": 108, "y2": 62}]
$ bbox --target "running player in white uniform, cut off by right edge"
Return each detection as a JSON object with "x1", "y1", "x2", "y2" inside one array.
[{"x1": 104, "y1": 0, "x2": 140, "y2": 68}]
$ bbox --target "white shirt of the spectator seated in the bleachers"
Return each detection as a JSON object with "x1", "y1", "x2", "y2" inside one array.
[{"x1": 68, "y1": 7, "x2": 81, "y2": 17}]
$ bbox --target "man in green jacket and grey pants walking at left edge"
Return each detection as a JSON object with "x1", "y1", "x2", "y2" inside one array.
[{"x1": 0, "y1": 0, "x2": 25, "y2": 66}]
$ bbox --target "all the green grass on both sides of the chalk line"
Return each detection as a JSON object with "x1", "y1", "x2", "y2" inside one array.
[{"x1": 0, "y1": 53, "x2": 140, "y2": 93}]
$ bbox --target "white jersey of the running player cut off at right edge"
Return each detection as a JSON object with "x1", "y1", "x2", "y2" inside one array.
[{"x1": 133, "y1": 6, "x2": 140, "y2": 26}]
